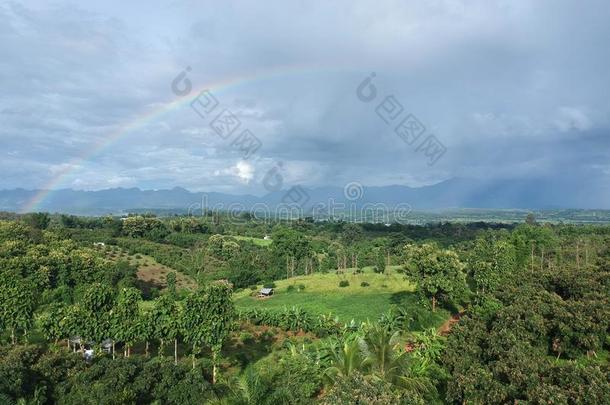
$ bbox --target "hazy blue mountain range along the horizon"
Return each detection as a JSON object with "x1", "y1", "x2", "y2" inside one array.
[{"x1": 0, "y1": 178, "x2": 610, "y2": 215}]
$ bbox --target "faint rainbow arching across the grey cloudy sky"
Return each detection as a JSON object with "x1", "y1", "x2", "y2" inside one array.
[{"x1": 21, "y1": 65, "x2": 346, "y2": 213}]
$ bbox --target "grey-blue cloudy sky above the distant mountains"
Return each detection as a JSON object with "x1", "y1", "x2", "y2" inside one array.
[{"x1": 0, "y1": 0, "x2": 610, "y2": 194}]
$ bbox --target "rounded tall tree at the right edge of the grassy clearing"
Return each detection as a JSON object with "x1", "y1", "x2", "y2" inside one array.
[{"x1": 405, "y1": 243, "x2": 466, "y2": 312}]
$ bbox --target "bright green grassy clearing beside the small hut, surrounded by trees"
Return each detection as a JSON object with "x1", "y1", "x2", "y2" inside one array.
[{"x1": 235, "y1": 269, "x2": 449, "y2": 327}]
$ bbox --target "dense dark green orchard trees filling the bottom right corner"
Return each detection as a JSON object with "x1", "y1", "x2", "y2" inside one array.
[{"x1": 443, "y1": 267, "x2": 610, "y2": 403}]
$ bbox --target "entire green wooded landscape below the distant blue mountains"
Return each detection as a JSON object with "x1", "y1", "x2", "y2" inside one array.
[{"x1": 0, "y1": 213, "x2": 610, "y2": 404}]
